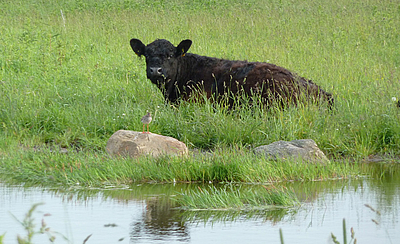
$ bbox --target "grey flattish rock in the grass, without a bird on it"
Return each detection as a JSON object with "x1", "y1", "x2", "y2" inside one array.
[{"x1": 254, "y1": 139, "x2": 329, "y2": 163}]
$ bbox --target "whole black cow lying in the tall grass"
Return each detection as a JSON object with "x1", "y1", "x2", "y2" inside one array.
[{"x1": 130, "y1": 39, "x2": 333, "y2": 107}]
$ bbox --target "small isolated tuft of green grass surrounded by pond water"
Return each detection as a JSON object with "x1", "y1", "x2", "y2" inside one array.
[{"x1": 175, "y1": 186, "x2": 298, "y2": 210}]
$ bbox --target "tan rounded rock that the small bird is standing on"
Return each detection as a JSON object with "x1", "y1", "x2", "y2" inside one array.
[{"x1": 106, "y1": 130, "x2": 188, "y2": 157}]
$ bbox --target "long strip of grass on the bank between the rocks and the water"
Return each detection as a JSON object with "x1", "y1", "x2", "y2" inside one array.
[{"x1": 0, "y1": 145, "x2": 359, "y2": 187}]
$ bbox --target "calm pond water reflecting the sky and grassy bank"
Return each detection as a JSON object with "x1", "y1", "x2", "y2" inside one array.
[{"x1": 0, "y1": 168, "x2": 400, "y2": 244}]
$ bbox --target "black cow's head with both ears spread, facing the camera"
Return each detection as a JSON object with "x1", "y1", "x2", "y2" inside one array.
[{"x1": 130, "y1": 39, "x2": 192, "y2": 88}]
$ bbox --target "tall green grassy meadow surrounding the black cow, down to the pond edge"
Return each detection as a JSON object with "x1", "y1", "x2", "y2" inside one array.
[{"x1": 0, "y1": 0, "x2": 400, "y2": 185}]
